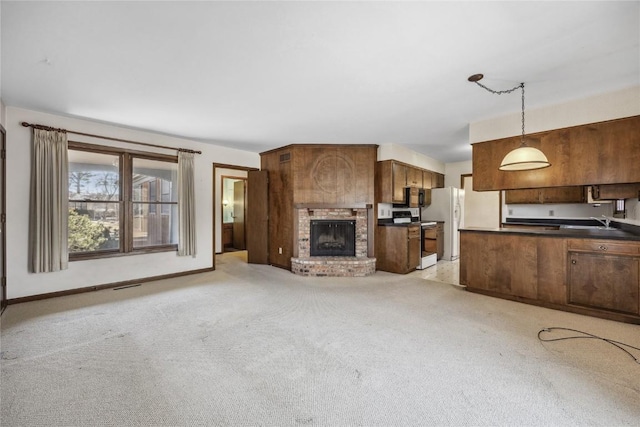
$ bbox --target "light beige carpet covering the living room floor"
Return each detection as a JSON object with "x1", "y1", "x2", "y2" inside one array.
[{"x1": 1, "y1": 253, "x2": 640, "y2": 426}]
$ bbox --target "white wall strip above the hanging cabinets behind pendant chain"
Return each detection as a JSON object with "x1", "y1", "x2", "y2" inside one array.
[{"x1": 469, "y1": 86, "x2": 640, "y2": 143}]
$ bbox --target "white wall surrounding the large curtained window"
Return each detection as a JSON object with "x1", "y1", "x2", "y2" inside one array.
[{"x1": 5, "y1": 106, "x2": 260, "y2": 299}]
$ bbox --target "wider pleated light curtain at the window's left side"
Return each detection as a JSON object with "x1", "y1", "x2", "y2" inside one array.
[{"x1": 29, "y1": 129, "x2": 69, "y2": 273}]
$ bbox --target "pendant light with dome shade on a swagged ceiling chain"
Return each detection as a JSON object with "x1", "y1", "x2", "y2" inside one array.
[{"x1": 468, "y1": 74, "x2": 551, "y2": 171}]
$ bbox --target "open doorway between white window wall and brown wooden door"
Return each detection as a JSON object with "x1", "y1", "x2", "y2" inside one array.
[{"x1": 221, "y1": 176, "x2": 247, "y2": 253}]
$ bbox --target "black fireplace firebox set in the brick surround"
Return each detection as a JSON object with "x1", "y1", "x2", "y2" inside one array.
[{"x1": 309, "y1": 219, "x2": 356, "y2": 256}]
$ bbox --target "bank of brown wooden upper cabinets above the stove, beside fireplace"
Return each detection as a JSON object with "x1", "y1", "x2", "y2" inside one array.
[{"x1": 376, "y1": 160, "x2": 444, "y2": 203}]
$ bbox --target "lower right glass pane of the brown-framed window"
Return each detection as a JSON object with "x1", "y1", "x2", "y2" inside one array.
[{"x1": 133, "y1": 203, "x2": 178, "y2": 248}]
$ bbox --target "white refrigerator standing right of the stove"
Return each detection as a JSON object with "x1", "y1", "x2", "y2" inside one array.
[{"x1": 420, "y1": 187, "x2": 464, "y2": 261}]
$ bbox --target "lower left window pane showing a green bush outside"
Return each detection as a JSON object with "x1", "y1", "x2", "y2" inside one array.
[{"x1": 69, "y1": 202, "x2": 120, "y2": 253}]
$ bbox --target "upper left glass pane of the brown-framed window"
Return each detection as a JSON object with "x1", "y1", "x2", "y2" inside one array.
[{"x1": 69, "y1": 150, "x2": 120, "y2": 201}]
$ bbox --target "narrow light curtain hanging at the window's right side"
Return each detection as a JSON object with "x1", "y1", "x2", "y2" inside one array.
[{"x1": 178, "y1": 151, "x2": 196, "y2": 257}]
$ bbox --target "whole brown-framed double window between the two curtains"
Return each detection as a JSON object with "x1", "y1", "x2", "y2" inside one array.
[{"x1": 69, "y1": 142, "x2": 178, "y2": 260}]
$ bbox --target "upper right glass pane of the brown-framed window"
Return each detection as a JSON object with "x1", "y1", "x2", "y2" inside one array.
[{"x1": 133, "y1": 158, "x2": 178, "y2": 202}]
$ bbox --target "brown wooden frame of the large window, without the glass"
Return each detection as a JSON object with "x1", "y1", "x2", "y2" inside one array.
[{"x1": 67, "y1": 141, "x2": 178, "y2": 261}]
